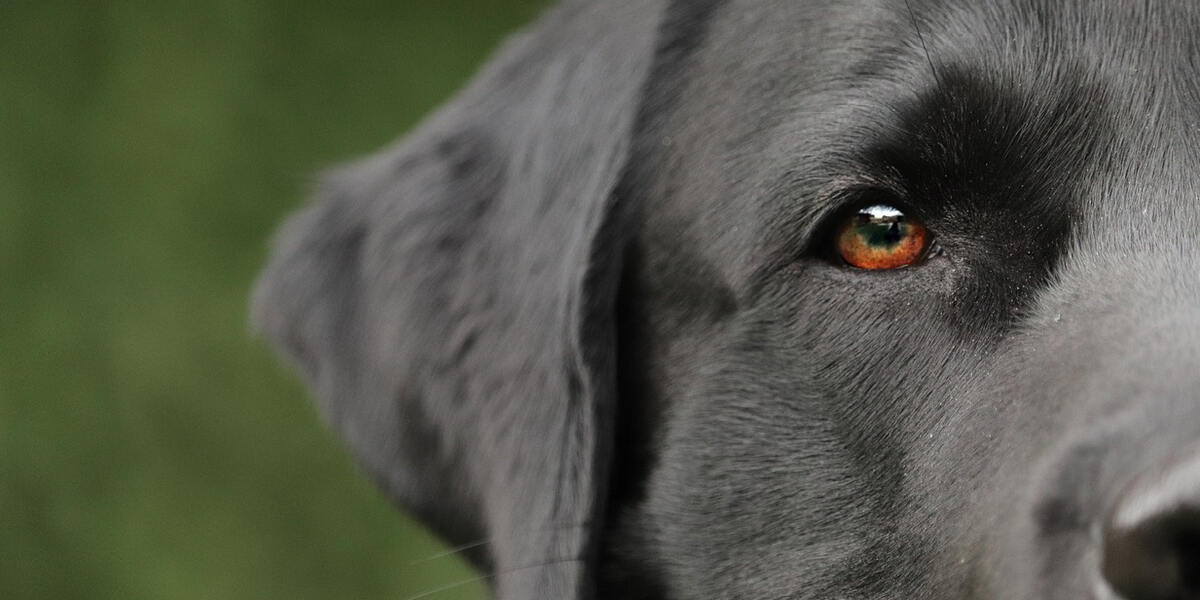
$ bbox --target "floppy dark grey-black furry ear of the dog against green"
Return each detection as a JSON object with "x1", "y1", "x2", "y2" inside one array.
[{"x1": 252, "y1": 0, "x2": 661, "y2": 600}]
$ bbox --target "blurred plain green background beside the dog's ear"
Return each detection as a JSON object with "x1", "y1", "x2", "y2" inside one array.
[{"x1": 0, "y1": 0, "x2": 544, "y2": 600}]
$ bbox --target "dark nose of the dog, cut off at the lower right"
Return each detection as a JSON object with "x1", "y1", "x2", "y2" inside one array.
[{"x1": 1102, "y1": 454, "x2": 1200, "y2": 600}]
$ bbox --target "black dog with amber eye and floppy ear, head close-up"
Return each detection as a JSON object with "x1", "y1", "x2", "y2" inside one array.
[{"x1": 256, "y1": 0, "x2": 1200, "y2": 600}]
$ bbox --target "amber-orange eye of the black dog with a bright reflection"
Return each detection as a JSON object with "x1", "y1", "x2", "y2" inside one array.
[{"x1": 835, "y1": 204, "x2": 929, "y2": 270}]
